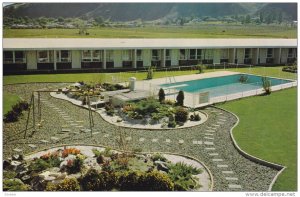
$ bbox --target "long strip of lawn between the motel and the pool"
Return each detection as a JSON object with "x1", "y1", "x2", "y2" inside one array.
[{"x1": 3, "y1": 67, "x2": 297, "y2": 84}]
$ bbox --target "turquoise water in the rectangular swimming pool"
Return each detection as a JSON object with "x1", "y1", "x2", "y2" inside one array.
[{"x1": 161, "y1": 74, "x2": 291, "y2": 97}]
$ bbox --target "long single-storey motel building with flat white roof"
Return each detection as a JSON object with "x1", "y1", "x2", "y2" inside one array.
[{"x1": 3, "y1": 38, "x2": 297, "y2": 74}]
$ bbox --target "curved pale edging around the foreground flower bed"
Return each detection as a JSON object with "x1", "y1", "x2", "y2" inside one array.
[{"x1": 24, "y1": 143, "x2": 214, "y2": 191}]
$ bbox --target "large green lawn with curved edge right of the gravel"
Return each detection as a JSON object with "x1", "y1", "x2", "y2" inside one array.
[{"x1": 219, "y1": 88, "x2": 297, "y2": 191}]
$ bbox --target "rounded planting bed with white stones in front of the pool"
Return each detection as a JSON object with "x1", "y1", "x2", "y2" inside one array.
[{"x1": 100, "y1": 98, "x2": 207, "y2": 129}]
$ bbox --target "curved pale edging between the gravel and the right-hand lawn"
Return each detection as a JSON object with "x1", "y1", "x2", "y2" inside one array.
[{"x1": 214, "y1": 106, "x2": 287, "y2": 191}]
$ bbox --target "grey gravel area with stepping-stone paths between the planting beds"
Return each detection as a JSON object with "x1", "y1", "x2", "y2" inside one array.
[{"x1": 3, "y1": 83, "x2": 278, "y2": 191}]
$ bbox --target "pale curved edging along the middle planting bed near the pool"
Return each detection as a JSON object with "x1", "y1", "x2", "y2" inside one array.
[{"x1": 49, "y1": 92, "x2": 209, "y2": 131}]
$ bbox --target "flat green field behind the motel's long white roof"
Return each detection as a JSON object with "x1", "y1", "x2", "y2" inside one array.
[{"x1": 3, "y1": 24, "x2": 297, "y2": 38}]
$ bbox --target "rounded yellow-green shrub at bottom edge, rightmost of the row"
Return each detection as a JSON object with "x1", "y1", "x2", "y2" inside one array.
[{"x1": 139, "y1": 171, "x2": 174, "y2": 191}]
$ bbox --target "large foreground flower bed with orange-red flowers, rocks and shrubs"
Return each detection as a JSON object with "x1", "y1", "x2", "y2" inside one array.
[{"x1": 3, "y1": 147, "x2": 210, "y2": 191}]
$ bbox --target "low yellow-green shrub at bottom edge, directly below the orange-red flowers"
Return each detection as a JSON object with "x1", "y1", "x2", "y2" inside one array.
[{"x1": 46, "y1": 178, "x2": 80, "y2": 191}]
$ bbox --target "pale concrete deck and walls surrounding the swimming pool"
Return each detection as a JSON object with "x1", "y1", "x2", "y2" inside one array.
[{"x1": 135, "y1": 71, "x2": 297, "y2": 108}]
